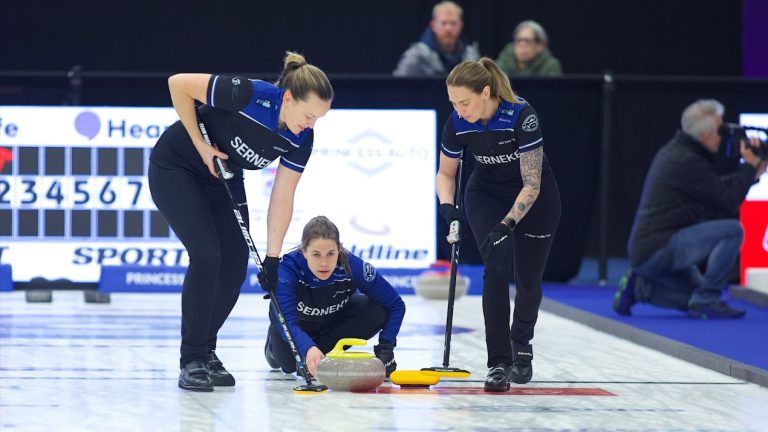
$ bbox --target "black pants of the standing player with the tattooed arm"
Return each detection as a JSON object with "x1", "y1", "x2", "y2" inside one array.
[{"x1": 464, "y1": 175, "x2": 560, "y2": 367}]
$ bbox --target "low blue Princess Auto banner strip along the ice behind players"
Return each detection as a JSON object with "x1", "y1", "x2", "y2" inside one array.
[{"x1": 94, "y1": 265, "x2": 483, "y2": 294}]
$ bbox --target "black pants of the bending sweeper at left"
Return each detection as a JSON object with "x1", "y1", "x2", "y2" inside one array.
[{"x1": 148, "y1": 162, "x2": 248, "y2": 367}]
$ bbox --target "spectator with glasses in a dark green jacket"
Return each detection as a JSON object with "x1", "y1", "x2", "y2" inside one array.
[{"x1": 496, "y1": 20, "x2": 563, "y2": 78}]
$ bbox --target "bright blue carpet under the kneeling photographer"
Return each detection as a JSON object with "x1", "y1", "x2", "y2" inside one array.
[{"x1": 543, "y1": 284, "x2": 768, "y2": 370}]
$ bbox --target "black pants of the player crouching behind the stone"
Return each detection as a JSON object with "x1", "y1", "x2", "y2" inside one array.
[{"x1": 269, "y1": 294, "x2": 388, "y2": 373}]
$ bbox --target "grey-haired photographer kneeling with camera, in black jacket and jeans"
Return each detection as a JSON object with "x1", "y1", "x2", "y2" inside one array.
[{"x1": 613, "y1": 100, "x2": 766, "y2": 319}]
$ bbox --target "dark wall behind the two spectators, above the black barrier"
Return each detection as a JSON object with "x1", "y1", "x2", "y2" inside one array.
[{"x1": 0, "y1": 0, "x2": 742, "y2": 76}]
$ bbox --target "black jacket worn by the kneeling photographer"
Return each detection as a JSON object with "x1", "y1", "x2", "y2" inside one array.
[{"x1": 628, "y1": 131, "x2": 756, "y2": 267}]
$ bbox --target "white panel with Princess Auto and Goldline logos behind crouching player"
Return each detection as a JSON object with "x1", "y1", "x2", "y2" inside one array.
[{"x1": 245, "y1": 109, "x2": 437, "y2": 268}]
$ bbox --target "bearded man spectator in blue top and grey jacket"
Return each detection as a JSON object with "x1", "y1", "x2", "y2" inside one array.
[{"x1": 393, "y1": 1, "x2": 480, "y2": 77}]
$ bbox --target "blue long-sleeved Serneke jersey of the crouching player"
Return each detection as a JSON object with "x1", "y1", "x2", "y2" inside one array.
[{"x1": 275, "y1": 250, "x2": 405, "y2": 354}]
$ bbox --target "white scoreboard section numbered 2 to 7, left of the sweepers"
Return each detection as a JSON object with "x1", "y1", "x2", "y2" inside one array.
[{"x1": 0, "y1": 107, "x2": 184, "y2": 282}]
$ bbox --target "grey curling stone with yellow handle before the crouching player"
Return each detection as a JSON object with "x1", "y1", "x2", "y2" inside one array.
[{"x1": 317, "y1": 338, "x2": 386, "y2": 391}]
